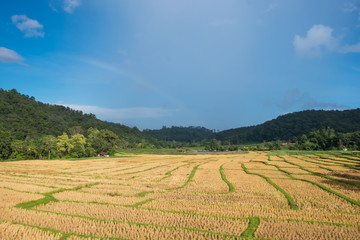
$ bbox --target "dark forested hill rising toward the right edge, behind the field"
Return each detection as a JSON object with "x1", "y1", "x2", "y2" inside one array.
[{"x1": 214, "y1": 109, "x2": 360, "y2": 144}]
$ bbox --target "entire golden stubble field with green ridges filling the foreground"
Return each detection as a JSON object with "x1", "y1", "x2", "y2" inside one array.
[{"x1": 0, "y1": 152, "x2": 360, "y2": 240}]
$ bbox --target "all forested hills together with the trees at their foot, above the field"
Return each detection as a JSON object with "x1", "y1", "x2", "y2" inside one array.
[{"x1": 0, "y1": 89, "x2": 360, "y2": 159}]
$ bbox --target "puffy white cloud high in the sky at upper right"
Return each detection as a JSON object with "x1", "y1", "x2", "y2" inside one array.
[{"x1": 293, "y1": 25, "x2": 339, "y2": 57}]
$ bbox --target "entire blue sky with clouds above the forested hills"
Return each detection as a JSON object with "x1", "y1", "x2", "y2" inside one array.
[{"x1": 0, "y1": 0, "x2": 360, "y2": 130}]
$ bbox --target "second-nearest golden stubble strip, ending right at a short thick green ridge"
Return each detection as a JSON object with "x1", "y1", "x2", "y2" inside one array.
[{"x1": 38, "y1": 202, "x2": 247, "y2": 235}]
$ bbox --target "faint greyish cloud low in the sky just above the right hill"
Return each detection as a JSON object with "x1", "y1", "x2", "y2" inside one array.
[{"x1": 276, "y1": 89, "x2": 350, "y2": 110}]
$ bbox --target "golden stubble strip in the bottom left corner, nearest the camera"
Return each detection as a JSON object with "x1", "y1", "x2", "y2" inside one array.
[{"x1": 0, "y1": 209, "x2": 238, "y2": 239}]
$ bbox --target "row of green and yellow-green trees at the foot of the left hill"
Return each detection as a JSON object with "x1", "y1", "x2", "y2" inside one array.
[{"x1": 0, "y1": 128, "x2": 122, "y2": 160}]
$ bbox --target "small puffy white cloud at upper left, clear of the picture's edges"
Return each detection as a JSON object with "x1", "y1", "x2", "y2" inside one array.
[{"x1": 11, "y1": 15, "x2": 44, "y2": 37}]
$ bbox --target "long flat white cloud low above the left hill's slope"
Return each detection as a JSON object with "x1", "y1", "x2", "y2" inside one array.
[{"x1": 61, "y1": 104, "x2": 176, "y2": 121}]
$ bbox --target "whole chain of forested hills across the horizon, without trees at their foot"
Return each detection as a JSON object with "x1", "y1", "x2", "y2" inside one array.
[{"x1": 0, "y1": 89, "x2": 360, "y2": 144}]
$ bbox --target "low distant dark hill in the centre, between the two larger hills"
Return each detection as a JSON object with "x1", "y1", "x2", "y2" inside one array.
[{"x1": 143, "y1": 126, "x2": 213, "y2": 142}]
